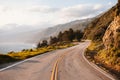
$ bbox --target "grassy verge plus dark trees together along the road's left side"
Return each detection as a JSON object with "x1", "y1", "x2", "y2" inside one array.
[{"x1": 0, "y1": 29, "x2": 83, "y2": 64}]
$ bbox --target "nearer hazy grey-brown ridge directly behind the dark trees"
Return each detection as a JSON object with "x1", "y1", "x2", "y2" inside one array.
[{"x1": 29, "y1": 18, "x2": 94, "y2": 42}]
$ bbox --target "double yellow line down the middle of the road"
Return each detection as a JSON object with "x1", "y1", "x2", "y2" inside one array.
[{"x1": 50, "y1": 54, "x2": 65, "y2": 80}]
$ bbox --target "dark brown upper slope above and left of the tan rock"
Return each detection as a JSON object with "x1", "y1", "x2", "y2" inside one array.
[{"x1": 84, "y1": 6, "x2": 117, "y2": 40}]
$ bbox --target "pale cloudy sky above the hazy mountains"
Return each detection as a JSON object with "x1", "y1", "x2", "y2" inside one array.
[{"x1": 0, "y1": 0, "x2": 117, "y2": 30}]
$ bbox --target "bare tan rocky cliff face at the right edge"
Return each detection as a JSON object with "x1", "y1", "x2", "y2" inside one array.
[{"x1": 103, "y1": 16, "x2": 120, "y2": 49}]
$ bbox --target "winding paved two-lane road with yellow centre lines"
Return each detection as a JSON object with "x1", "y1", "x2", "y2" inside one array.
[{"x1": 0, "y1": 41, "x2": 115, "y2": 80}]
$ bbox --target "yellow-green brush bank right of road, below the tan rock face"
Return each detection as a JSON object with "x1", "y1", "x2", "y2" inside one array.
[{"x1": 85, "y1": 42, "x2": 120, "y2": 79}]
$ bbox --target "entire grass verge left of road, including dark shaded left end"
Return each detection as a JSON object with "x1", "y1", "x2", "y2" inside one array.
[{"x1": 0, "y1": 43, "x2": 74, "y2": 64}]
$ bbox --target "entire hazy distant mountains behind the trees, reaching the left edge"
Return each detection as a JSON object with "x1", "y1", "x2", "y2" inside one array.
[{"x1": 0, "y1": 18, "x2": 93, "y2": 43}]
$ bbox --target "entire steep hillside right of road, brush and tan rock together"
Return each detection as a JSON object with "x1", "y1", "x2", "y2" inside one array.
[{"x1": 84, "y1": 0, "x2": 120, "y2": 78}]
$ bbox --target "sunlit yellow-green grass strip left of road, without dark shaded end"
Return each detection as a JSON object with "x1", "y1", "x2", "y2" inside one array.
[{"x1": 7, "y1": 43, "x2": 74, "y2": 60}]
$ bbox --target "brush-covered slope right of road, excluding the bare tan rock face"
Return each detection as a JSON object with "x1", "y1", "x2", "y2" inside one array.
[{"x1": 84, "y1": 2, "x2": 120, "y2": 77}]
